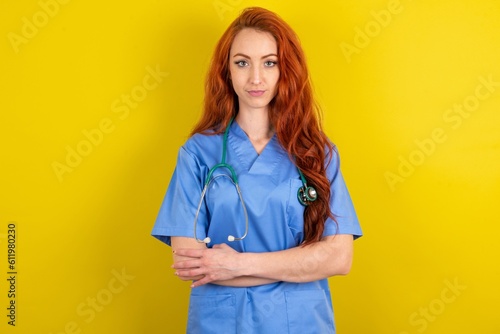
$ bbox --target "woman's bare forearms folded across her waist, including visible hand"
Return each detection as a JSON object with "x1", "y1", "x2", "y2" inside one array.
[{"x1": 172, "y1": 234, "x2": 353, "y2": 287}]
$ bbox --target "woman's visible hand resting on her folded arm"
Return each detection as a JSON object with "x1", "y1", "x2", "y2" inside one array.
[{"x1": 172, "y1": 244, "x2": 241, "y2": 288}]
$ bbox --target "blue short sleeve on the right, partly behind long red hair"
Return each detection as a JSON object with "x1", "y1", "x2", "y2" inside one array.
[{"x1": 323, "y1": 147, "x2": 363, "y2": 239}]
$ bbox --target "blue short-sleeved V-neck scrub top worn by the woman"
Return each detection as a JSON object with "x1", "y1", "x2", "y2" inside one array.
[{"x1": 152, "y1": 122, "x2": 362, "y2": 334}]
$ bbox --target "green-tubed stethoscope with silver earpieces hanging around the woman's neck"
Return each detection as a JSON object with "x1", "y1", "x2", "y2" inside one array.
[{"x1": 194, "y1": 119, "x2": 318, "y2": 244}]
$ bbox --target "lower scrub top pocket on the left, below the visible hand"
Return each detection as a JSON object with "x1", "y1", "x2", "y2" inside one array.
[{"x1": 187, "y1": 294, "x2": 236, "y2": 334}]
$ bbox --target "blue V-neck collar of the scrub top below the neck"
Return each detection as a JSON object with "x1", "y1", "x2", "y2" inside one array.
[{"x1": 228, "y1": 121, "x2": 286, "y2": 175}]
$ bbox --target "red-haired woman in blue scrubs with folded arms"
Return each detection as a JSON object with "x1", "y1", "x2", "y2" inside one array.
[{"x1": 152, "y1": 8, "x2": 361, "y2": 334}]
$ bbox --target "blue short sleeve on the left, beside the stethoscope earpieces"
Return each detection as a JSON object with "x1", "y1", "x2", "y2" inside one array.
[{"x1": 151, "y1": 147, "x2": 207, "y2": 245}]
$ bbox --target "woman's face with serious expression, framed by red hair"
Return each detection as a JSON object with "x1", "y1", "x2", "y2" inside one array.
[{"x1": 229, "y1": 29, "x2": 280, "y2": 112}]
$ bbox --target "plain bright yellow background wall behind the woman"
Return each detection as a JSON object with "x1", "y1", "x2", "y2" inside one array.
[{"x1": 0, "y1": 0, "x2": 500, "y2": 334}]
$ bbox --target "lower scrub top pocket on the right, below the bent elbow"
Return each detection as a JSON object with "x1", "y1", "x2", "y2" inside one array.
[{"x1": 285, "y1": 290, "x2": 335, "y2": 334}]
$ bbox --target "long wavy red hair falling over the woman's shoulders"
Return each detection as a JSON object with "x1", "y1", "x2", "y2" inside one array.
[{"x1": 192, "y1": 7, "x2": 333, "y2": 245}]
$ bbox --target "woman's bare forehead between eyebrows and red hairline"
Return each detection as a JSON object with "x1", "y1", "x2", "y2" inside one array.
[{"x1": 231, "y1": 28, "x2": 278, "y2": 56}]
